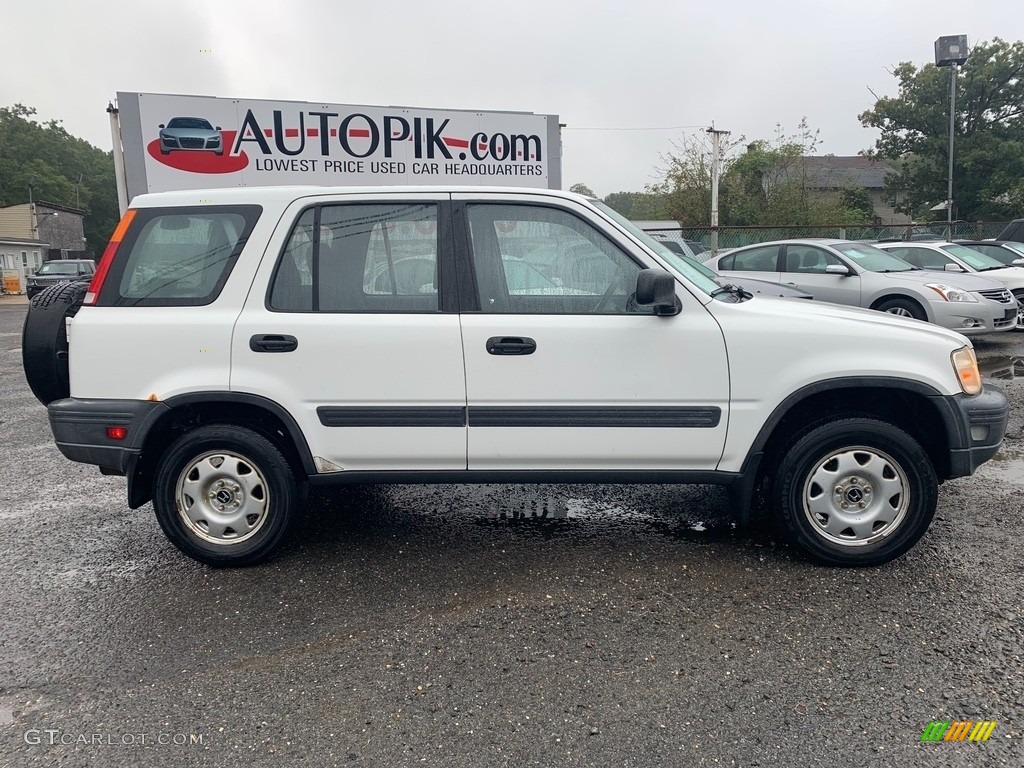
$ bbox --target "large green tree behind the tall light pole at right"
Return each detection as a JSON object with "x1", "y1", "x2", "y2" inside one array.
[{"x1": 860, "y1": 38, "x2": 1024, "y2": 220}]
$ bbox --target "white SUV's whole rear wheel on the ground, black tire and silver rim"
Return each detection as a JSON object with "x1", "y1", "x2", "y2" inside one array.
[{"x1": 153, "y1": 424, "x2": 301, "y2": 565}]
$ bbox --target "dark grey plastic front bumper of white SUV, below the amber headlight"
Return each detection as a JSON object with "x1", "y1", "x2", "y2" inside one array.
[{"x1": 932, "y1": 384, "x2": 1010, "y2": 478}]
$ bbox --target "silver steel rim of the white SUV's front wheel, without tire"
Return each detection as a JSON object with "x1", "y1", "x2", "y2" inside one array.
[{"x1": 802, "y1": 446, "x2": 910, "y2": 547}]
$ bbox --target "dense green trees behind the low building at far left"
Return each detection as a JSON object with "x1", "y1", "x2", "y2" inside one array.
[{"x1": 0, "y1": 104, "x2": 119, "y2": 254}]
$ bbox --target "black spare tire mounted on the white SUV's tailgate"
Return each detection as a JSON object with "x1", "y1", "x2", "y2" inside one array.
[{"x1": 22, "y1": 282, "x2": 89, "y2": 406}]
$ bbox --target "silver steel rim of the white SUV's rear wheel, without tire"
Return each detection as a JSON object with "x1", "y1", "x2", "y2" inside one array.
[{"x1": 174, "y1": 451, "x2": 269, "y2": 545}]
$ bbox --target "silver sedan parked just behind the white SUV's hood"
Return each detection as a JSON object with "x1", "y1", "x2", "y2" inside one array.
[{"x1": 708, "y1": 239, "x2": 1018, "y2": 335}]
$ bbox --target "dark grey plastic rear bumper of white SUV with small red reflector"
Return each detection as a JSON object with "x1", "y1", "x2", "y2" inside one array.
[{"x1": 46, "y1": 397, "x2": 169, "y2": 474}]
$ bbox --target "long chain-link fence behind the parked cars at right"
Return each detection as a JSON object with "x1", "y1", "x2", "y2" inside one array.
[{"x1": 647, "y1": 221, "x2": 1009, "y2": 258}]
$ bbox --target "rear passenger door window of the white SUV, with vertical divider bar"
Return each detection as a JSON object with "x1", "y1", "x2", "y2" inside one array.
[{"x1": 269, "y1": 203, "x2": 440, "y2": 312}]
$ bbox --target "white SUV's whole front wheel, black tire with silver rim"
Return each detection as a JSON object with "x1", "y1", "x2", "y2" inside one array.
[{"x1": 771, "y1": 418, "x2": 938, "y2": 566}]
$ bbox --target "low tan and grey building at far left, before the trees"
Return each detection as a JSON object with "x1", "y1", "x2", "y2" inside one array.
[{"x1": 0, "y1": 203, "x2": 91, "y2": 293}]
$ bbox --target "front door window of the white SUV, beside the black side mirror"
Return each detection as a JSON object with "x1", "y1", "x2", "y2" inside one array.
[{"x1": 468, "y1": 204, "x2": 651, "y2": 314}]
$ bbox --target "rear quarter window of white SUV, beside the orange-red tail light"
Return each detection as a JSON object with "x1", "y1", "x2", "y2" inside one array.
[{"x1": 96, "y1": 206, "x2": 262, "y2": 306}]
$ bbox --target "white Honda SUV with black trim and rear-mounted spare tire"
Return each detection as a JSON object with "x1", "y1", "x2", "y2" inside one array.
[{"x1": 24, "y1": 187, "x2": 1007, "y2": 565}]
